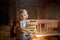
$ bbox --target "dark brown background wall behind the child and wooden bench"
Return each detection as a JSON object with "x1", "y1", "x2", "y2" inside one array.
[{"x1": 0, "y1": 0, "x2": 60, "y2": 25}]
